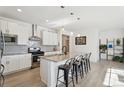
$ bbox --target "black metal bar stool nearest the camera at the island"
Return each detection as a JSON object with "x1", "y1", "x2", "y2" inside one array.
[{"x1": 56, "y1": 58, "x2": 75, "y2": 87}]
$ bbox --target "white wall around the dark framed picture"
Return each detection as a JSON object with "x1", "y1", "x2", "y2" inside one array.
[{"x1": 71, "y1": 29, "x2": 99, "y2": 62}]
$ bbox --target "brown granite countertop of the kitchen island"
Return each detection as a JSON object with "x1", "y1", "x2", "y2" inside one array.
[{"x1": 41, "y1": 54, "x2": 77, "y2": 62}]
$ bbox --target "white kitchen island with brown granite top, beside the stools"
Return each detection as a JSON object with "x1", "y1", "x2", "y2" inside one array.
[{"x1": 40, "y1": 54, "x2": 76, "y2": 87}]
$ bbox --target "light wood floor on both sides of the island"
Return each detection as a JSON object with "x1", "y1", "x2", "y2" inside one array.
[{"x1": 4, "y1": 61, "x2": 124, "y2": 87}]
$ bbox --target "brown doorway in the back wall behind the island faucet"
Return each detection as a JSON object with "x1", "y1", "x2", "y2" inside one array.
[{"x1": 62, "y1": 34, "x2": 70, "y2": 54}]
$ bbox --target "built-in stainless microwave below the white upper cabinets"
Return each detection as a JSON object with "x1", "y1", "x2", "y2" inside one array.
[{"x1": 4, "y1": 34, "x2": 18, "y2": 44}]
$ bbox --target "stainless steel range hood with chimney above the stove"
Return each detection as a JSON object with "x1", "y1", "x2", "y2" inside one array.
[{"x1": 29, "y1": 24, "x2": 41, "y2": 41}]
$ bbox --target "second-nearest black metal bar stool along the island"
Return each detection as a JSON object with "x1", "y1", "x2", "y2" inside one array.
[{"x1": 73, "y1": 55, "x2": 83, "y2": 83}]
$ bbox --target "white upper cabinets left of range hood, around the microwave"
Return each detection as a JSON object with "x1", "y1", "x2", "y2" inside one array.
[{"x1": 0, "y1": 19, "x2": 32, "y2": 45}]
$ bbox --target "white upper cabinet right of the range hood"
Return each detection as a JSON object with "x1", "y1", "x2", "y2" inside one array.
[{"x1": 42, "y1": 31, "x2": 58, "y2": 45}]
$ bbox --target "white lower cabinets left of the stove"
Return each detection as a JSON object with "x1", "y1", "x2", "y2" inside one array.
[{"x1": 2, "y1": 54, "x2": 31, "y2": 74}]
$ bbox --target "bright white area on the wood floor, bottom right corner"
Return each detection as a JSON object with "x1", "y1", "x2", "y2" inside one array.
[{"x1": 103, "y1": 68, "x2": 124, "y2": 87}]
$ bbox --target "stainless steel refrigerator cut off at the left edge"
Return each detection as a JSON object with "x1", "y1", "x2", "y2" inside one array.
[{"x1": 0, "y1": 30, "x2": 5, "y2": 87}]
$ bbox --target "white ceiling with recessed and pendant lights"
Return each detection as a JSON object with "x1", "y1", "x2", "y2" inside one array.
[{"x1": 0, "y1": 6, "x2": 124, "y2": 31}]
